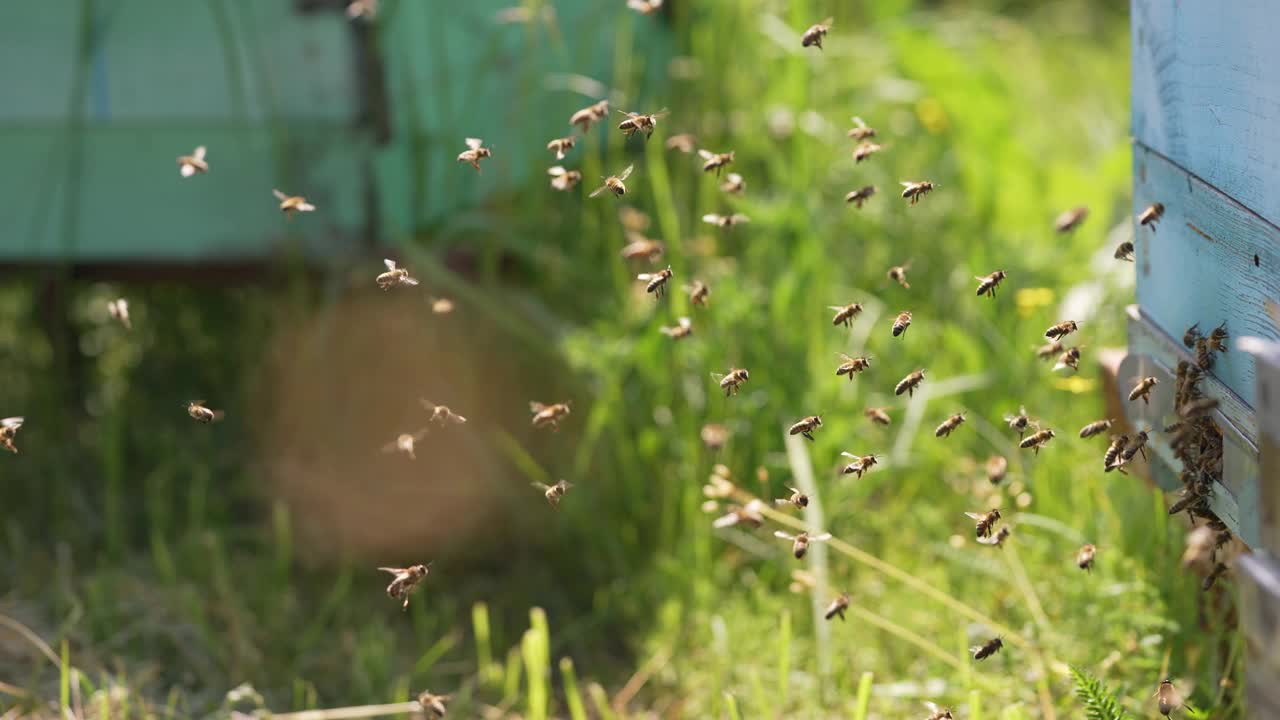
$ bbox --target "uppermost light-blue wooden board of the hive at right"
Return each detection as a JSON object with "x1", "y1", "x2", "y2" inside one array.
[{"x1": 1130, "y1": 0, "x2": 1280, "y2": 224}]
